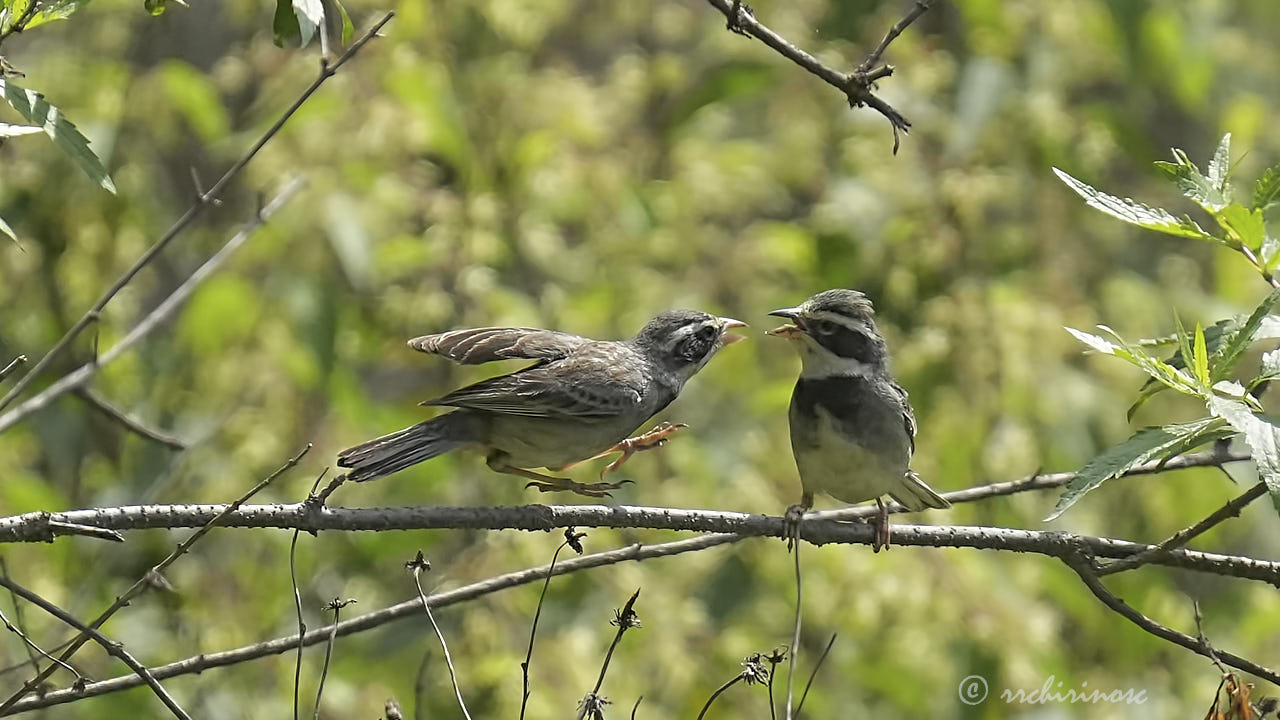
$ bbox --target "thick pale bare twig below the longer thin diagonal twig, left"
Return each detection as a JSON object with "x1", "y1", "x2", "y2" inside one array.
[{"x1": 0, "y1": 178, "x2": 303, "y2": 433}]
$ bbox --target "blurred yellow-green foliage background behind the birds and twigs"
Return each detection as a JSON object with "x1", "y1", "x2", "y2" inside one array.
[{"x1": 0, "y1": 0, "x2": 1280, "y2": 719}]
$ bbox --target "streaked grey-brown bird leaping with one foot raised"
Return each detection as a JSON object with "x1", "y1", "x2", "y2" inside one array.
[{"x1": 338, "y1": 310, "x2": 746, "y2": 497}]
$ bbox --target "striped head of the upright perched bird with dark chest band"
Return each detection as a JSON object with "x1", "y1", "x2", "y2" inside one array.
[{"x1": 769, "y1": 290, "x2": 888, "y2": 377}]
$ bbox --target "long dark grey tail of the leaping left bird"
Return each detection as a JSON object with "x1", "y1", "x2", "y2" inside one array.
[{"x1": 338, "y1": 411, "x2": 479, "y2": 483}]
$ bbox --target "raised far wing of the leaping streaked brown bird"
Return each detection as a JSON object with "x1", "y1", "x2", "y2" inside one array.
[{"x1": 408, "y1": 328, "x2": 591, "y2": 365}]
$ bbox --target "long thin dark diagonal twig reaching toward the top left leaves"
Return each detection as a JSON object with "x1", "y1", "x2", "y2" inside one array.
[{"x1": 0, "y1": 11, "x2": 396, "y2": 412}]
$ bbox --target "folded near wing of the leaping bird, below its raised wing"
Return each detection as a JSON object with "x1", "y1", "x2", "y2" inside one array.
[{"x1": 422, "y1": 342, "x2": 645, "y2": 420}]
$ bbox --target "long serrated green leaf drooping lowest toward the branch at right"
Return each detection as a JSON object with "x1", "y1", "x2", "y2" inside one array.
[{"x1": 1044, "y1": 418, "x2": 1231, "y2": 521}]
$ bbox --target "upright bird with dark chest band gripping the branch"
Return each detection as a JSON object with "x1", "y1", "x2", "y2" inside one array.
[{"x1": 767, "y1": 290, "x2": 951, "y2": 552}]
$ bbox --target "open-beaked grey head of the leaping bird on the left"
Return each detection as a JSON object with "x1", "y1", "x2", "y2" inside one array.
[{"x1": 631, "y1": 310, "x2": 746, "y2": 380}]
